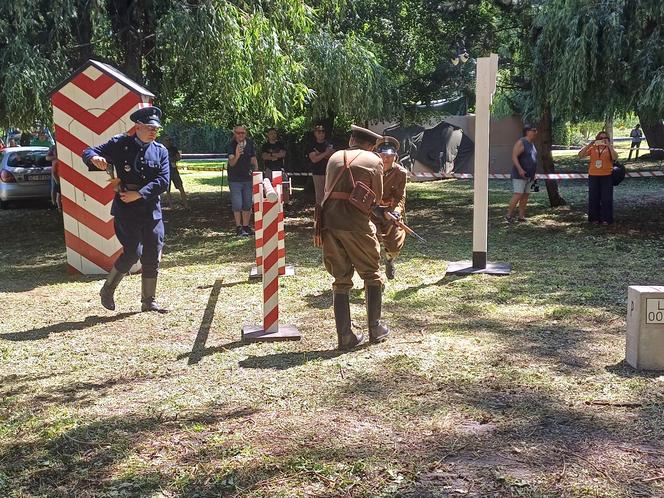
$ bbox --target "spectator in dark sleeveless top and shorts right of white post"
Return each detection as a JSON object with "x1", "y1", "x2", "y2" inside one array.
[{"x1": 505, "y1": 124, "x2": 537, "y2": 223}]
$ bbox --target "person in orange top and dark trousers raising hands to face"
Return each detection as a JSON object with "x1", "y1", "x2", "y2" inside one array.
[{"x1": 579, "y1": 131, "x2": 618, "y2": 225}]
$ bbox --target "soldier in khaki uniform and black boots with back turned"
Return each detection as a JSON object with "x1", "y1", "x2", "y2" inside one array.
[{"x1": 316, "y1": 125, "x2": 389, "y2": 350}]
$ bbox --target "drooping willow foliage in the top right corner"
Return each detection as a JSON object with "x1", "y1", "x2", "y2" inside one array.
[{"x1": 532, "y1": 0, "x2": 664, "y2": 118}]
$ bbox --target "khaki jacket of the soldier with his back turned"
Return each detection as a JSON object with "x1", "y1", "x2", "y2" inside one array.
[{"x1": 323, "y1": 148, "x2": 383, "y2": 233}]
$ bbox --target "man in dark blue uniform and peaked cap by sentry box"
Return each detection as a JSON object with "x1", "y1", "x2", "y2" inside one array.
[{"x1": 83, "y1": 106, "x2": 170, "y2": 313}]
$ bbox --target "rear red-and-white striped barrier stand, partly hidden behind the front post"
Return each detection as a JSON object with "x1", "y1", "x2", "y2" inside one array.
[{"x1": 249, "y1": 171, "x2": 295, "y2": 279}]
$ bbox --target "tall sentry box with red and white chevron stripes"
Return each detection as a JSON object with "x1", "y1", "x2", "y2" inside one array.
[{"x1": 51, "y1": 60, "x2": 154, "y2": 275}]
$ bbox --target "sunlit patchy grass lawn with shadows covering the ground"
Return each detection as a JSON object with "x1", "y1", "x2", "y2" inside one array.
[{"x1": 0, "y1": 171, "x2": 664, "y2": 498}]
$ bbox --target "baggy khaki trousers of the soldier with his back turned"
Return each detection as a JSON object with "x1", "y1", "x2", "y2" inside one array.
[{"x1": 321, "y1": 228, "x2": 383, "y2": 294}]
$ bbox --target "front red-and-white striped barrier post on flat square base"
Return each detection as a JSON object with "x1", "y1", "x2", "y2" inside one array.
[{"x1": 242, "y1": 173, "x2": 300, "y2": 342}]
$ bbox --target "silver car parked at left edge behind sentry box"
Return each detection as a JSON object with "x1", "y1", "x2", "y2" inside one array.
[{"x1": 0, "y1": 147, "x2": 51, "y2": 209}]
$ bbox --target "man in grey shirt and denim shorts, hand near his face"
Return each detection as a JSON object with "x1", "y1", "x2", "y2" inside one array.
[{"x1": 227, "y1": 125, "x2": 258, "y2": 236}]
